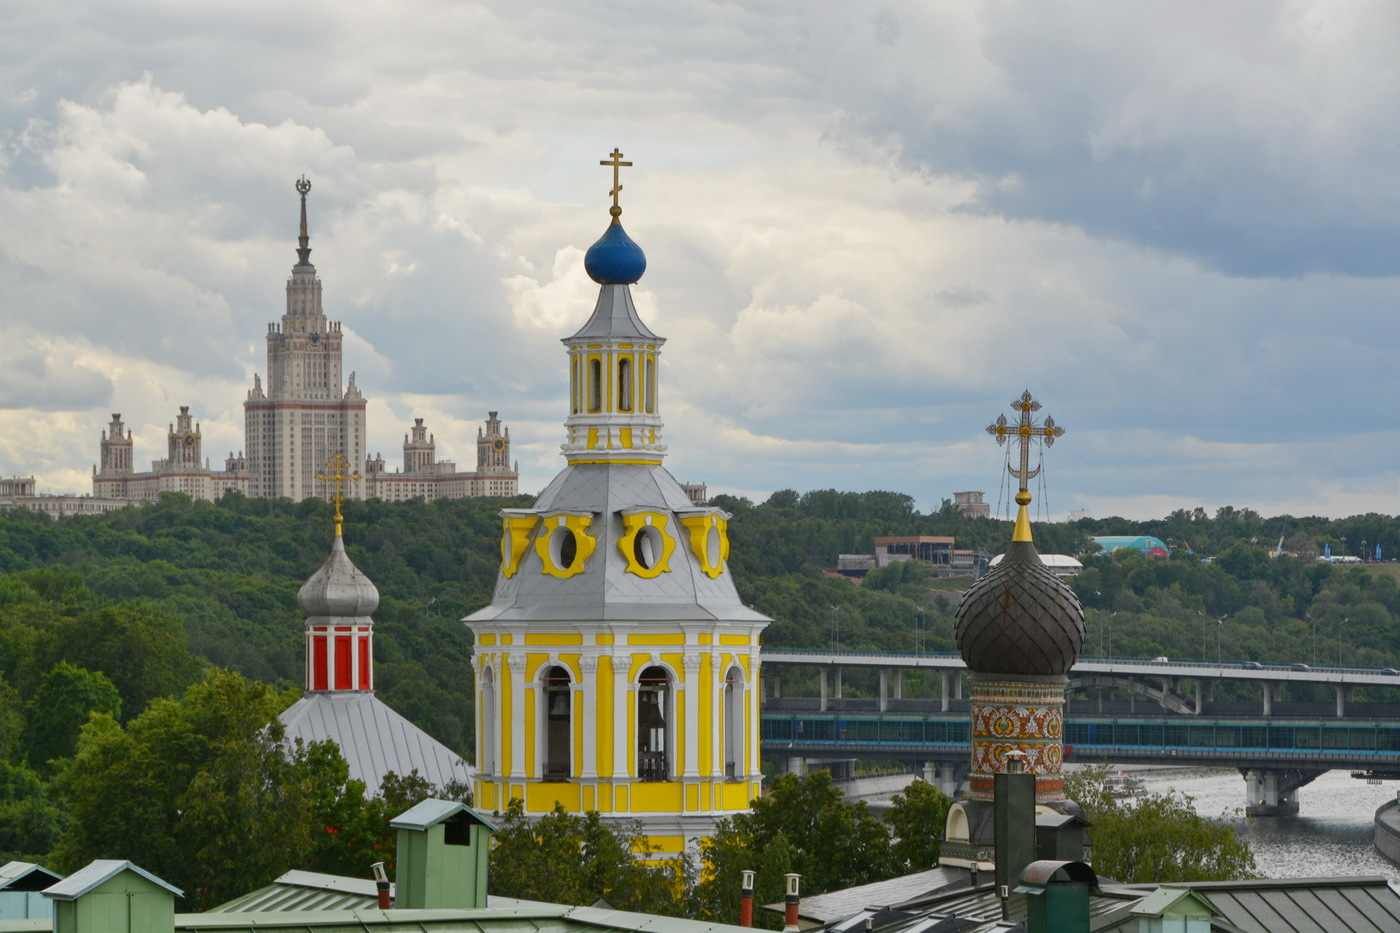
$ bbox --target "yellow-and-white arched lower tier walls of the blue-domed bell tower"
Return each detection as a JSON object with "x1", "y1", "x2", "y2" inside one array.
[{"x1": 476, "y1": 626, "x2": 760, "y2": 855}]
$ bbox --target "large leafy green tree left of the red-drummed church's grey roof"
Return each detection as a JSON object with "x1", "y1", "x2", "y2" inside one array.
[{"x1": 52, "y1": 670, "x2": 389, "y2": 908}]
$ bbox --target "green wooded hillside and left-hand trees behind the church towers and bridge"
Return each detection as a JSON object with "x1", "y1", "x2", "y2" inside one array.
[{"x1": 0, "y1": 481, "x2": 1400, "y2": 897}]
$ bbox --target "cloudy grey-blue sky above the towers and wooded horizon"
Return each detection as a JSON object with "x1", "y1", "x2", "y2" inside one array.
[{"x1": 0, "y1": 0, "x2": 1400, "y2": 518}]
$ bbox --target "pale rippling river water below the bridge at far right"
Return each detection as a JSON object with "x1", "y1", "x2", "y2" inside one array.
[{"x1": 1135, "y1": 768, "x2": 1400, "y2": 881}]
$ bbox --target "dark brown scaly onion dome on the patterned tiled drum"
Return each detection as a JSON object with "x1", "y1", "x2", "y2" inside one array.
[{"x1": 955, "y1": 535, "x2": 1084, "y2": 675}]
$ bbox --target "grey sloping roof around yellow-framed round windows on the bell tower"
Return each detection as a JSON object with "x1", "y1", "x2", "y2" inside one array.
[{"x1": 466, "y1": 464, "x2": 769, "y2": 625}]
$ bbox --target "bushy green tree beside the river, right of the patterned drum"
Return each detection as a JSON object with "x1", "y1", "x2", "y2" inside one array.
[{"x1": 1065, "y1": 768, "x2": 1257, "y2": 884}]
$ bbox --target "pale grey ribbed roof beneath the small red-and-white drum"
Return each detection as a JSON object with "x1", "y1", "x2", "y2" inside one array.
[{"x1": 279, "y1": 692, "x2": 475, "y2": 796}]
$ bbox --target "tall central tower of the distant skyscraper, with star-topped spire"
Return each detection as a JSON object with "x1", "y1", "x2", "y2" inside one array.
[{"x1": 244, "y1": 178, "x2": 368, "y2": 502}]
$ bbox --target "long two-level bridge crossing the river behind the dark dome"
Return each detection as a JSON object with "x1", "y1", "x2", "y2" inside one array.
[{"x1": 763, "y1": 651, "x2": 1400, "y2": 815}]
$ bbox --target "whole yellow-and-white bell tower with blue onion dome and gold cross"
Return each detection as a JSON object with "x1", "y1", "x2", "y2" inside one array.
[{"x1": 465, "y1": 150, "x2": 770, "y2": 856}]
